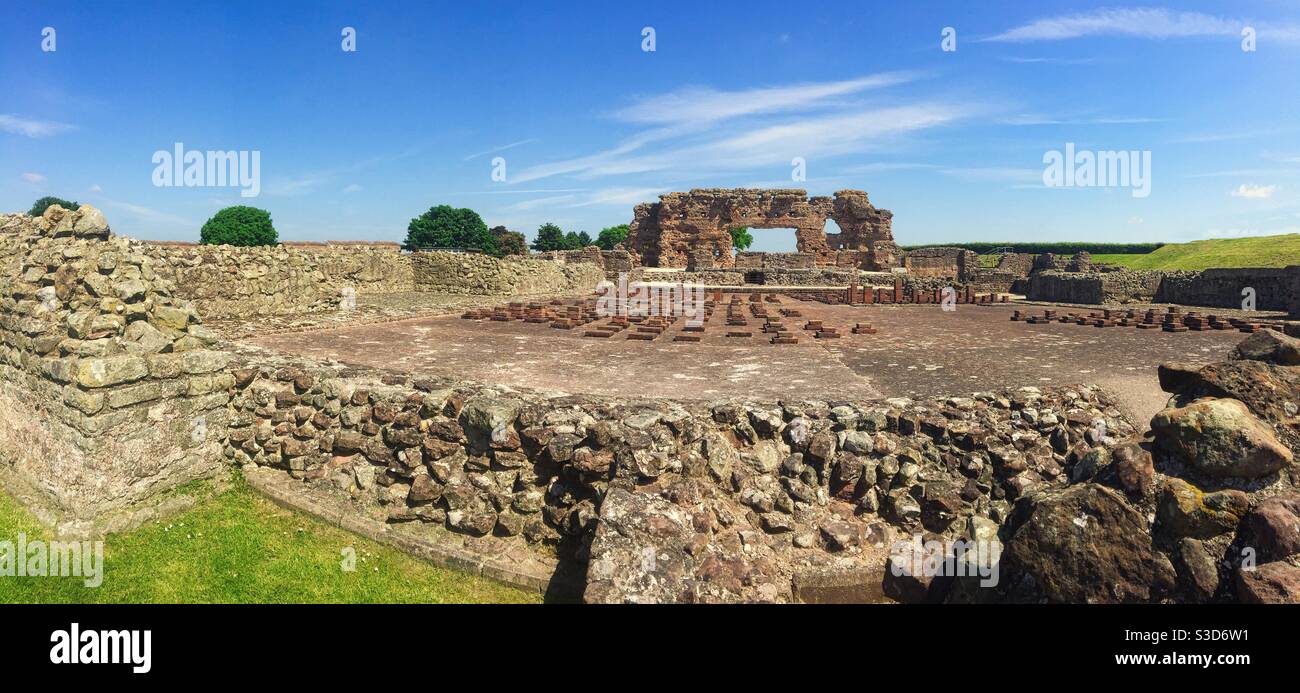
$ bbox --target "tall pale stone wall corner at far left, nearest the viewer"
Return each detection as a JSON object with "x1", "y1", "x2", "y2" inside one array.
[{"x1": 0, "y1": 205, "x2": 233, "y2": 533}]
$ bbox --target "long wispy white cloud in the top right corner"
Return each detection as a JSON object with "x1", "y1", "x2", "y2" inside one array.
[{"x1": 980, "y1": 8, "x2": 1300, "y2": 42}]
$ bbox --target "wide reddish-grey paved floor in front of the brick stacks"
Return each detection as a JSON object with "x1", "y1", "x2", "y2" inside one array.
[{"x1": 250, "y1": 298, "x2": 1245, "y2": 424}]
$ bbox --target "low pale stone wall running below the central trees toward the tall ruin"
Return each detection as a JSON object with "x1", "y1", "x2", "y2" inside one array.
[{"x1": 411, "y1": 251, "x2": 605, "y2": 295}]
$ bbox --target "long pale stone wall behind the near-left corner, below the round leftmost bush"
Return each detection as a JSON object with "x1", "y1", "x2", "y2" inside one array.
[{"x1": 138, "y1": 242, "x2": 413, "y2": 319}]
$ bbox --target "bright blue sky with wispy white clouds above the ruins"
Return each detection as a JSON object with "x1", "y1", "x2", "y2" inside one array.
[{"x1": 0, "y1": 0, "x2": 1300, "y2": 250}]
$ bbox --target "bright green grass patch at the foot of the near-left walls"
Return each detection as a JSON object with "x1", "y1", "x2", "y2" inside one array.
[{"x1": 0, "y1": 481, "x2": 541, "y2": 603}]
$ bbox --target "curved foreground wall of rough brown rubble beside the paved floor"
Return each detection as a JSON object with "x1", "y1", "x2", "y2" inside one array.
[{"x1": 225, "y1": 335, "x2": 1132, "y2": 602}]
